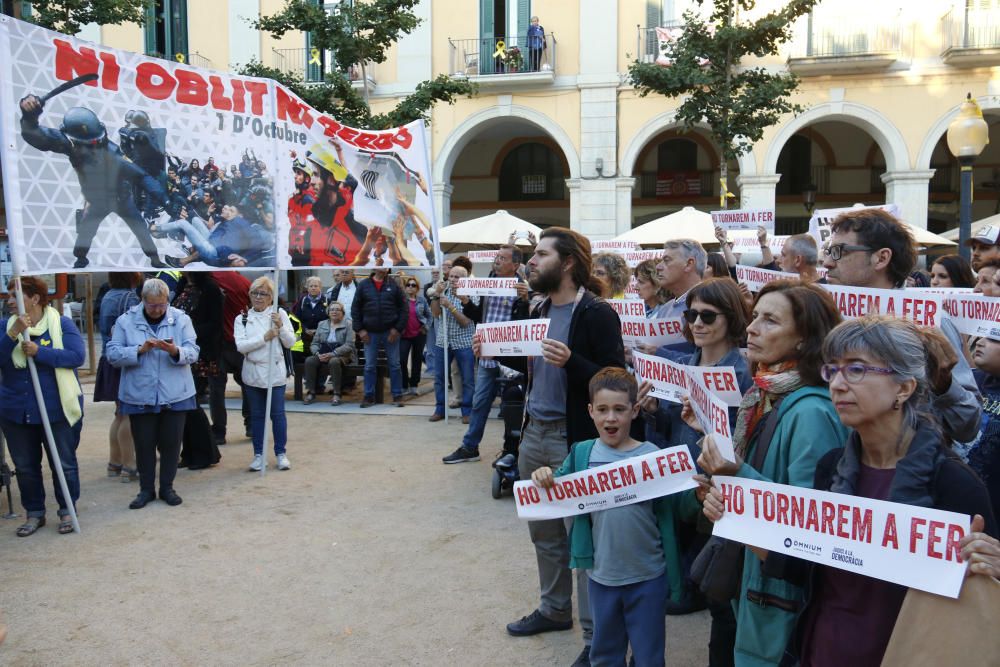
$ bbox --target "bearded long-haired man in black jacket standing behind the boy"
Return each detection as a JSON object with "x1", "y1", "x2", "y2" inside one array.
[{"x1": 474, "y1": 227, "x2": 625, "y2": 665}]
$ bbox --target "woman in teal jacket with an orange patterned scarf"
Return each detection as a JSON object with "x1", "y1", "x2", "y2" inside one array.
[{"x1": 685, "y1": 280, "x2": 847, "y2": 667}]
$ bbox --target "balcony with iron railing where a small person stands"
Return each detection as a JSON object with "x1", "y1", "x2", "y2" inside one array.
[{"x1": 448, "y1": 33, "x2": 556, "y2": 86}]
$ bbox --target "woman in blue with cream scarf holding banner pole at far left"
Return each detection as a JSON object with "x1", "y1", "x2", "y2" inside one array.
[{"x1": 0, "y1": 277, "x2": 84, "y2": 537}]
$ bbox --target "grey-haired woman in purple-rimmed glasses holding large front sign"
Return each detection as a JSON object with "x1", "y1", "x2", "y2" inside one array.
[{"x1": 705, "y1": 315, "x2": 998, "y2": 667}]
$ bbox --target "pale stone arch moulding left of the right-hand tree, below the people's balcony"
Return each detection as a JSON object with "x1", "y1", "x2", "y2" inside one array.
[{"x1": 433, "y1": 104, "x2": 580, "y2": 183}]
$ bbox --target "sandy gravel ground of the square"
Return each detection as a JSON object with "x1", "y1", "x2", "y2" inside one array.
[{"x1": 0, "y1": 387, "x2": 709, "y2": 666}]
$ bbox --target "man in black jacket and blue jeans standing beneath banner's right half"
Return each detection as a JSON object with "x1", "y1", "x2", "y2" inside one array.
[{"x1": 351, "y1": 269, "x2": 409, "y2": 408}]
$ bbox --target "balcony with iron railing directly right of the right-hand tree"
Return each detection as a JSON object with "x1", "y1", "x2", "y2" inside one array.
[{"x1": 788, "y1": 14, "x2": 903, "y2": 75}]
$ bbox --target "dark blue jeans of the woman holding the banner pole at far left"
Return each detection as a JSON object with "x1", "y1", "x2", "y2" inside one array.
[{"x1": 0, "y1": 418, "x2": 83, "y2": 519}]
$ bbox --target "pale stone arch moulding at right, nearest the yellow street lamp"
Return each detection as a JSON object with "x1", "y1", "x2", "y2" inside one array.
[{"x1": 764, "y1": 102, "x2": 910, "y2": 174}]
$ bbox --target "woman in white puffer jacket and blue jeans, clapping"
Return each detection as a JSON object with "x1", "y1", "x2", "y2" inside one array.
[{"x1": 233, "y1": 276, "x2": 295, "y2": 470}]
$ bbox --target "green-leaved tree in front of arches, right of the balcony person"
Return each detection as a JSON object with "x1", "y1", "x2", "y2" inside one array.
[{"x1": 629, "y1": 0, "x2": 819, "y2": 208}]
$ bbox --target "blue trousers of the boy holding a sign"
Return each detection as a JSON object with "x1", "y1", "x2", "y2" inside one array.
[{"x1": 588, "y1": 572, "x2": 670, "y2": 667}]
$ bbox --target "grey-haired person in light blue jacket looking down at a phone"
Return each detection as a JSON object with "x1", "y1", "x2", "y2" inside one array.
[{"x1": 106, "y1": 278, "x2": 199, "y2": 509}]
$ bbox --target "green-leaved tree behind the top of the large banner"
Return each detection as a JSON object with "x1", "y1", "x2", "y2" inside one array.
[{"x1": 242, "y1": 0, "x2": 476, "y2": 130}]
